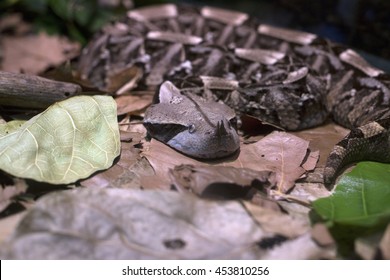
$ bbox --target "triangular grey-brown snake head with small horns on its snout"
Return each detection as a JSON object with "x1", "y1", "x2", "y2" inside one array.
[{"x1": 144, "y1": 81, "x2": 240, "y2": 159}]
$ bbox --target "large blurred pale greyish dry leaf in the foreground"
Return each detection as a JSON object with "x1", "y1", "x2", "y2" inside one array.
[{"x1": 0, "y1": 188, "x2": 304, "y2": 259}]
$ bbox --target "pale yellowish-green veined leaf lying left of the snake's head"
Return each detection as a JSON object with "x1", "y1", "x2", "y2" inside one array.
[{"x1": 0, "y1": 96, "x2": 120, "y2": 184}]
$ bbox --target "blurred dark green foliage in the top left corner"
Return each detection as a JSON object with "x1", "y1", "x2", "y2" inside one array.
[{"x1": 0, "y1": 0, "x2": 132, "y2": 44}]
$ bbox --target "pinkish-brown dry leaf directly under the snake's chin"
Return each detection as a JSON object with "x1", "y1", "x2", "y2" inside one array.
[{"x1": 143, "y1": 132, "x2": 310, "y2": 192}]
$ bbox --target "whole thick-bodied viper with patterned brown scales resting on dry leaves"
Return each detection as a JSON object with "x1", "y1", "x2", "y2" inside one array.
[{"x1": 79, "y1": 4, "x2": 390, "y2": 185}]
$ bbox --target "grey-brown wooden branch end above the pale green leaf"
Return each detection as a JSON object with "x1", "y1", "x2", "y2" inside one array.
[{"x1": 0, "y1": 71, "x2": 81, "y2": 108}]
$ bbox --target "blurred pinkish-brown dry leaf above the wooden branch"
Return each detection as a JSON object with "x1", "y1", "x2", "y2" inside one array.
[{"x1": 2, "y1": 33, "x2": 80, "y2": 74}]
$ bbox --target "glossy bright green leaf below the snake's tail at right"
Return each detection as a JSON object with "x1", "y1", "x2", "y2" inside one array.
[{"x1": 313, "y1": 162, "x2": 390, "y2": 227}]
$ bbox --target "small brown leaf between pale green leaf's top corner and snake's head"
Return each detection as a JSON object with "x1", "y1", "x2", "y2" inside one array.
[{"x1": 115, "y1": 94, "x2": 153, "y2": 115}]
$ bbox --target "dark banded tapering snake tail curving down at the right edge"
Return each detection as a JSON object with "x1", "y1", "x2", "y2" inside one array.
[{"x1": 324, "y1": 118, "x2": 390, "y2": 186}]
